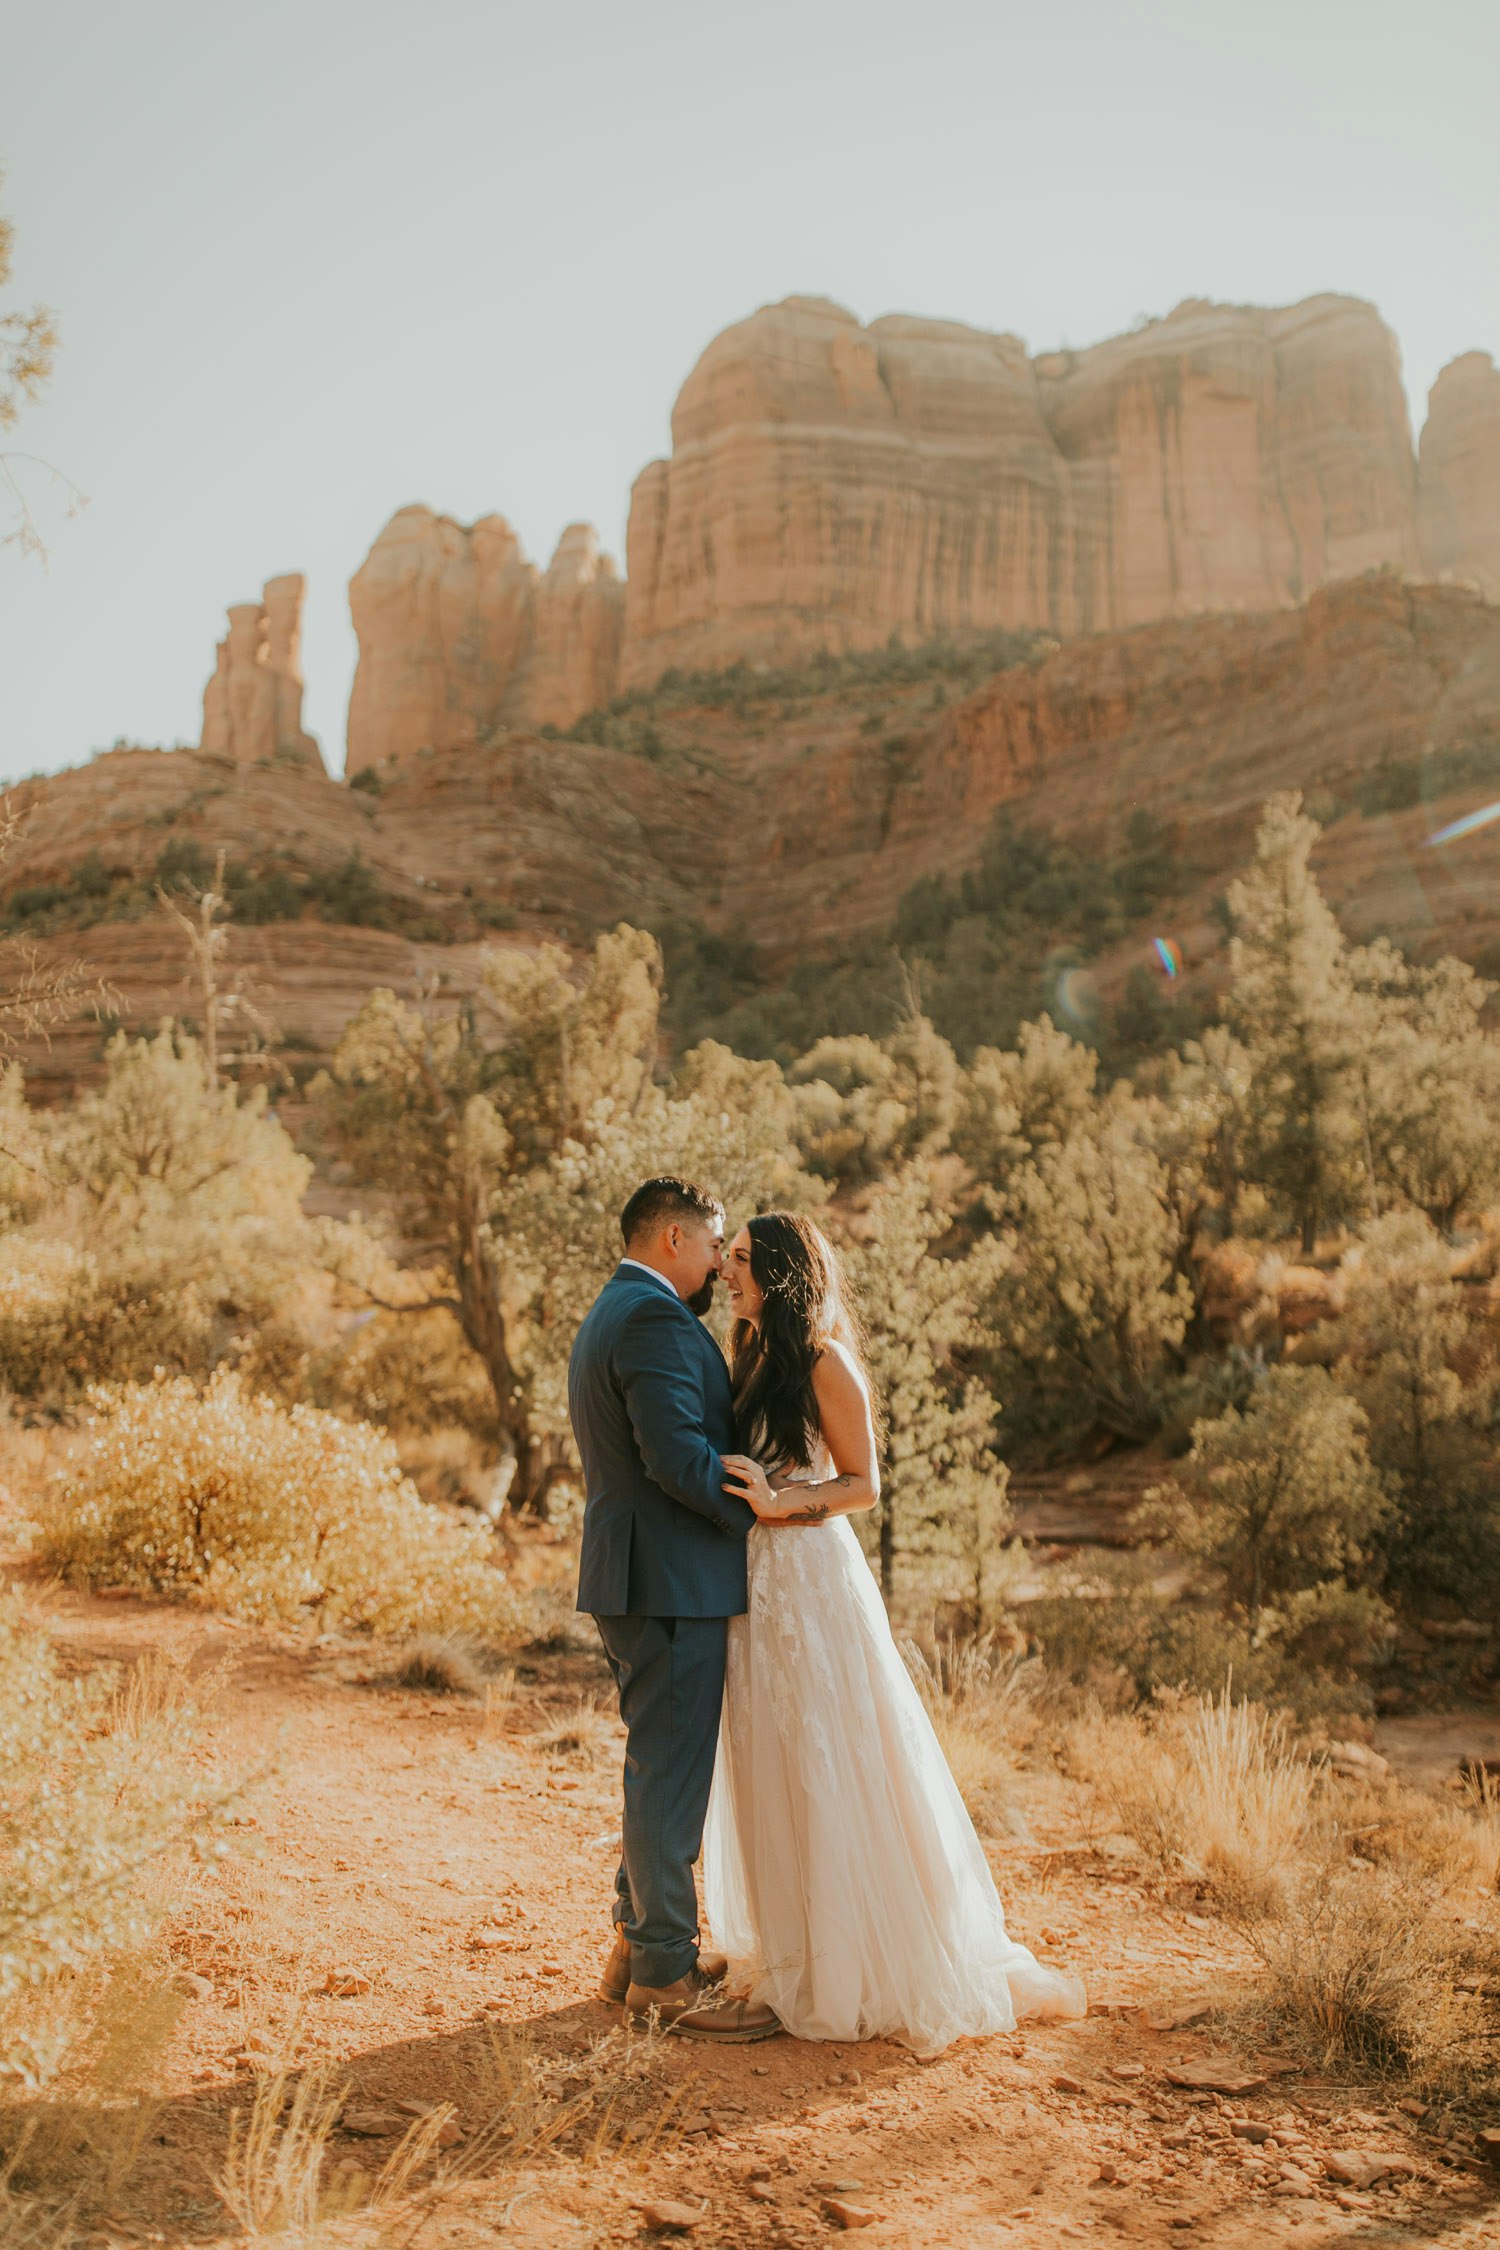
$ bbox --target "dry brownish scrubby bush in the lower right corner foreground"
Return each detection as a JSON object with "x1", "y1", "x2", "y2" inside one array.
[{"x1": 1250, "y1": 1863, "x2": 1498, "y2": 2095}]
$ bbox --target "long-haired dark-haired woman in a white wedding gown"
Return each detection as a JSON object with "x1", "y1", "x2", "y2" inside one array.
[{"x1": 704, "y1": 1213, "x2": 1084, "y2": 2054}]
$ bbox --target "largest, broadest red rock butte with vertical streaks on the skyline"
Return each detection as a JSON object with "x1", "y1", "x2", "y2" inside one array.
[{"x1": 623, "y1": 297, "x2": 1417, "y2": 684}]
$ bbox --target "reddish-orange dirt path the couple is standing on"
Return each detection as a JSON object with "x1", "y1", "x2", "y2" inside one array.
[{"x1": 17, "y1": 1589, "x2": 1500, "y2": 2250}]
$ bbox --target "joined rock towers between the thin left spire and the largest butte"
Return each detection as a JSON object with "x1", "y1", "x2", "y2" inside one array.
[{"x1": 344, "y1": 506, "x2": 623, "y2": 774}]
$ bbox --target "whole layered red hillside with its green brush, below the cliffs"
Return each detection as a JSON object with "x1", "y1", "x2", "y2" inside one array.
[{"x1": 0, "y1": 574, "x2": 1500, "y2": 1089}]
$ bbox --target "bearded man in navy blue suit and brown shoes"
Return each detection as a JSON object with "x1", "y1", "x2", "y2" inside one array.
[{"x1": 567, "y1": 1177, "x2": 780, "y2": 2043}]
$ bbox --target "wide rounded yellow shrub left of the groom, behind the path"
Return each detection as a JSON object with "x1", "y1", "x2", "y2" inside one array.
[{"x1": 40, "y1": 1370, "x2": 515, "y2": 1638}]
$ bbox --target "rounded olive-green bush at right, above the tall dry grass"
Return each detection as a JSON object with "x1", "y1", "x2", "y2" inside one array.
[{"x1": 1149, "y1": 1368, "x2": 1388, "y2": 1634}]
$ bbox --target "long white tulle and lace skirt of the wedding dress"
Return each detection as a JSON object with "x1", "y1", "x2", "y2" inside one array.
[{"x1": 704, "y1": 1465, "x2": 1086, "y2": 2054}]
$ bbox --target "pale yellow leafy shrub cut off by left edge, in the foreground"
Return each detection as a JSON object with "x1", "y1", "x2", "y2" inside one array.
[{"x1": 0, "y1": 1595, "x2": 229, "y2": 2088}]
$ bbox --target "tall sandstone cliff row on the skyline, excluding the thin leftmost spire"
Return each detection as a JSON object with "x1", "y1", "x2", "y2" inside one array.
[{"x1": 349, "y1": 295, "x2": 1500, "y2": 747}]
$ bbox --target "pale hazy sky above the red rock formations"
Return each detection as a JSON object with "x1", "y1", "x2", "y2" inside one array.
[{"x1": 0, "y1": 0, "x2": 1500, "y2": 779}]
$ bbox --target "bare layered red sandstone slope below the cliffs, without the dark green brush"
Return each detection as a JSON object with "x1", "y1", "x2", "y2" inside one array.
[{"x1": 0, "y1": 574, "x2": 1500, "y2": 1089}]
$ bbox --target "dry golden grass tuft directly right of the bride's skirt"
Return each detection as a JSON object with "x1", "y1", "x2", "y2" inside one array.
[{"x1": 902, "y1": 1631, "x2": 1041, "y2": 1836}]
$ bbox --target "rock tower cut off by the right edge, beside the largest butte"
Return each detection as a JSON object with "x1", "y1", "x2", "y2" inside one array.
[{"x1": 1421, "y1": 351, "x2": 1500, "y2": 601}]
